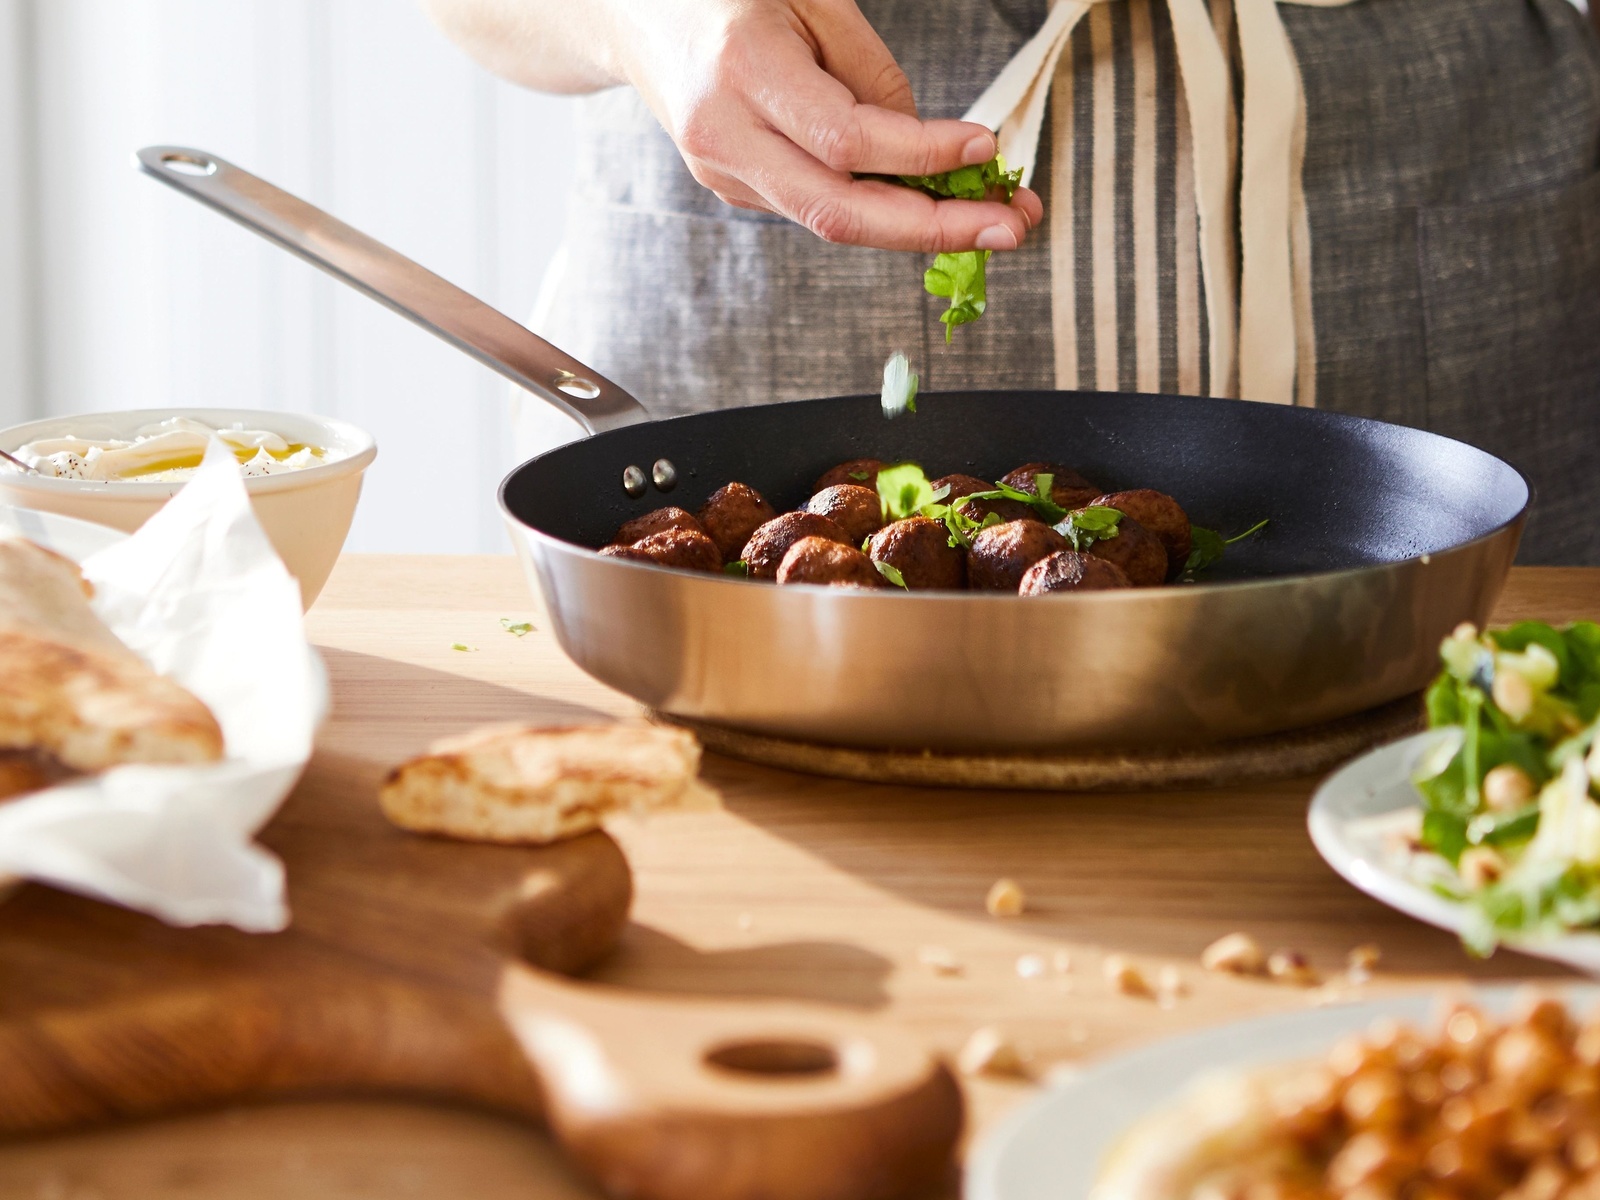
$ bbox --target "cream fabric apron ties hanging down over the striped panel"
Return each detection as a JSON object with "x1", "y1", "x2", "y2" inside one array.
[{"x1": 966, "y1": 0, "x2": 1354, "y2": 405}]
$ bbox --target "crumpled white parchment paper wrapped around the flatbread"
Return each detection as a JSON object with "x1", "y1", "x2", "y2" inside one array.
[{"x1": 0, "y1": 442, "x2": 328, "y2": 931}]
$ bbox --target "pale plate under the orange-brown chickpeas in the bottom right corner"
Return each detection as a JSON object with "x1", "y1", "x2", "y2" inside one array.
[{"x1": 966, "y1": 987, "x2": 1600, "y2": 1200}]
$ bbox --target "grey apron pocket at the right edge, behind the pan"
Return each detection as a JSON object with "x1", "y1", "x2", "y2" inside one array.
[{"x1": 1418, "y1": 174, "x2": 1600, "y2": 565}]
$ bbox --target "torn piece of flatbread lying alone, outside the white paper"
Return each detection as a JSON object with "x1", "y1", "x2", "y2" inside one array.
[{"x1": 379, "y1": 725, "x2": 717, "y2": 843}]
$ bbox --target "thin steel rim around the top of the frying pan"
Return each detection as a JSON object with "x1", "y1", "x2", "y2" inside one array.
[{"x1": 496, "y1": 389, "x2": 1536, "y2": 603}]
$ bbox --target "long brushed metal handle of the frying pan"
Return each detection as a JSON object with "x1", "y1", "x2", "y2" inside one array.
[{"x1": 138, "y1": 146, "x2": 650, "y2": 434}]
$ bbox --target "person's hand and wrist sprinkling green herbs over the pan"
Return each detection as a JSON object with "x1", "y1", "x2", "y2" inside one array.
[{"x1": 606, "y1": 0, "x2": 1043, "y2": 251}]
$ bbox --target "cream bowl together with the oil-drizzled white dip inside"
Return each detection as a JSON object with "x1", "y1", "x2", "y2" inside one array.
[{"x1": 0, "y1": 408, "x2": 378, "y2": 608}]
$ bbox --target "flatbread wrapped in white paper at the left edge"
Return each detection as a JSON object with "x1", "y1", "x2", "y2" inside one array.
[{"x1": 0, "y1": 538, "x2": 222, "y2": 773}]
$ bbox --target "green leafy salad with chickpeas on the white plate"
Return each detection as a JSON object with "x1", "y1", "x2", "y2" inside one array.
[{"x1": 1413, "y1": 621, "x2": 1600, "y2": 954}]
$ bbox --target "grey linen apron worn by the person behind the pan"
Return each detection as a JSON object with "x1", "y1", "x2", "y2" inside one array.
[{"x1": 539, "y1": 0, "x2": 1600, "y2": 563}]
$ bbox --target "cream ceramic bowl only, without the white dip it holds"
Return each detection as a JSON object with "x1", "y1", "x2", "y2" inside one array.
[{"x1": 0, "y1": 408, "x2": 378, "y2": 608}]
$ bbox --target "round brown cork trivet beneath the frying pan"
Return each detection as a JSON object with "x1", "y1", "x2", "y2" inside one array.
[{"x1": 651, "y1": 696, "x2": 1422, "y2": 792}]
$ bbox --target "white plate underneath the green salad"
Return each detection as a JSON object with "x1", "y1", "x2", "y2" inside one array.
[{"x1": 1307, "y1": 733, "x2": 1600, "y2": 974}]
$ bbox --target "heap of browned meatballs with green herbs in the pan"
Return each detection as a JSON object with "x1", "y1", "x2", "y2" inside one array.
[{"x1": 600, "y1": 459, "x2": 1266, "y2": 595}]
